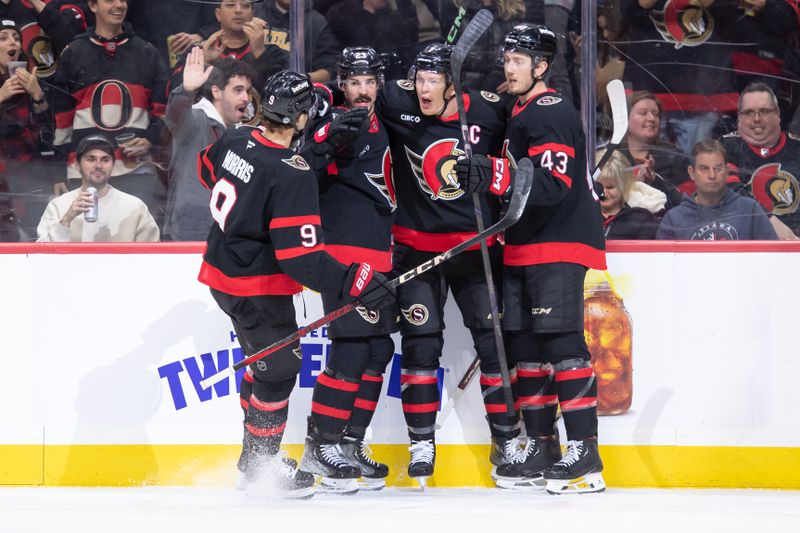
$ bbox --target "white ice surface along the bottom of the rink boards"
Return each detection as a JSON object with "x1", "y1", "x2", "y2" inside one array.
[{"x1": 0, "y1": 487, "x2": 800, "y2": 533}]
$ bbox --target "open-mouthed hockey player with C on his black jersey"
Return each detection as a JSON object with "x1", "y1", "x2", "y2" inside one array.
[{"x1": 377, "y1": 44, "x2": 519, "y2": 483}]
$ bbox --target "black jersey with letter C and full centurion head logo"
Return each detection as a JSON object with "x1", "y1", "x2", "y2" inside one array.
[{"x1": 376, "y1": 80, "x2": 505, "y2": 252}]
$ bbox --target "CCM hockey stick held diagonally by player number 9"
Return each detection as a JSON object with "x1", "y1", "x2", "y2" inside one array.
[{"x1": 200, "y1": 162, "x2": 533, "y2": 388}]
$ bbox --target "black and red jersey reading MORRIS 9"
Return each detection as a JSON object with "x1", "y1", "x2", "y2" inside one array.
[{"x1": 198, "y1": 126, "x2": 347, "y2": 296}]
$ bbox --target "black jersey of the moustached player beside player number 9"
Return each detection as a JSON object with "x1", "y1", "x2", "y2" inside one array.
[{"x1": 304, "y1": 108, "x2": 397, "y2": 272}]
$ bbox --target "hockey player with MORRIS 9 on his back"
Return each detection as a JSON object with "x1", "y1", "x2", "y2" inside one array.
[{"x1": 198, "y1": 71, "x2": 394, "y2": 497}]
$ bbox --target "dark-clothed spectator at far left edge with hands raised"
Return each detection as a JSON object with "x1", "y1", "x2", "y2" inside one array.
[{"x1": 0, "y1": 19, "x2": 55, "y2": 239}]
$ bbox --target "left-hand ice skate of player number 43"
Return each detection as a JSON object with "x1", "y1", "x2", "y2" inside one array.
[{"x1": 492, "y1": 438, "x2": 561, "y2": 490}]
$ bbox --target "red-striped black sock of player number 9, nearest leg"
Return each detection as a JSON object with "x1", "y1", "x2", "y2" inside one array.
[{"x1": 245, "y1": 378, "x2": 295, "y2": 455}]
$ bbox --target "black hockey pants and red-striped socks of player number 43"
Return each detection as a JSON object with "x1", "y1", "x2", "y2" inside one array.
[{"x1": 503, "y1": 263, "x2": 597, "y2": 440}]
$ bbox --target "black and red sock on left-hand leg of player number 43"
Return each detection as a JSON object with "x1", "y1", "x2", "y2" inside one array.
[{"x1": 517, "y1": 361, "x2": 558, "y2": 437}]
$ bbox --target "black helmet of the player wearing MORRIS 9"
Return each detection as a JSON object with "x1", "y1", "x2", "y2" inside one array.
[{"x1": 261, "y1": 70, "x2": 316, "y2": 127}]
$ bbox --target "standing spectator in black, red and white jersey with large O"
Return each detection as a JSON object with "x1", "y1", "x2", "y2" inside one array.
[{"x1": 53, "y1": 0, "x2": 169, "y2": 227}]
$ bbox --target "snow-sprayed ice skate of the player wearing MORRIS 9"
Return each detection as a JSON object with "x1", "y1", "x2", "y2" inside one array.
[{"x1": 244, "y1": 454, "x2": 316, "y2": 500}]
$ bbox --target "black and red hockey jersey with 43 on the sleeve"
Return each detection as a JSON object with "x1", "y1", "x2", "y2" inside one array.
[{"x1": 503, "y1": 89, "x2": 606, "y2": 270}]
